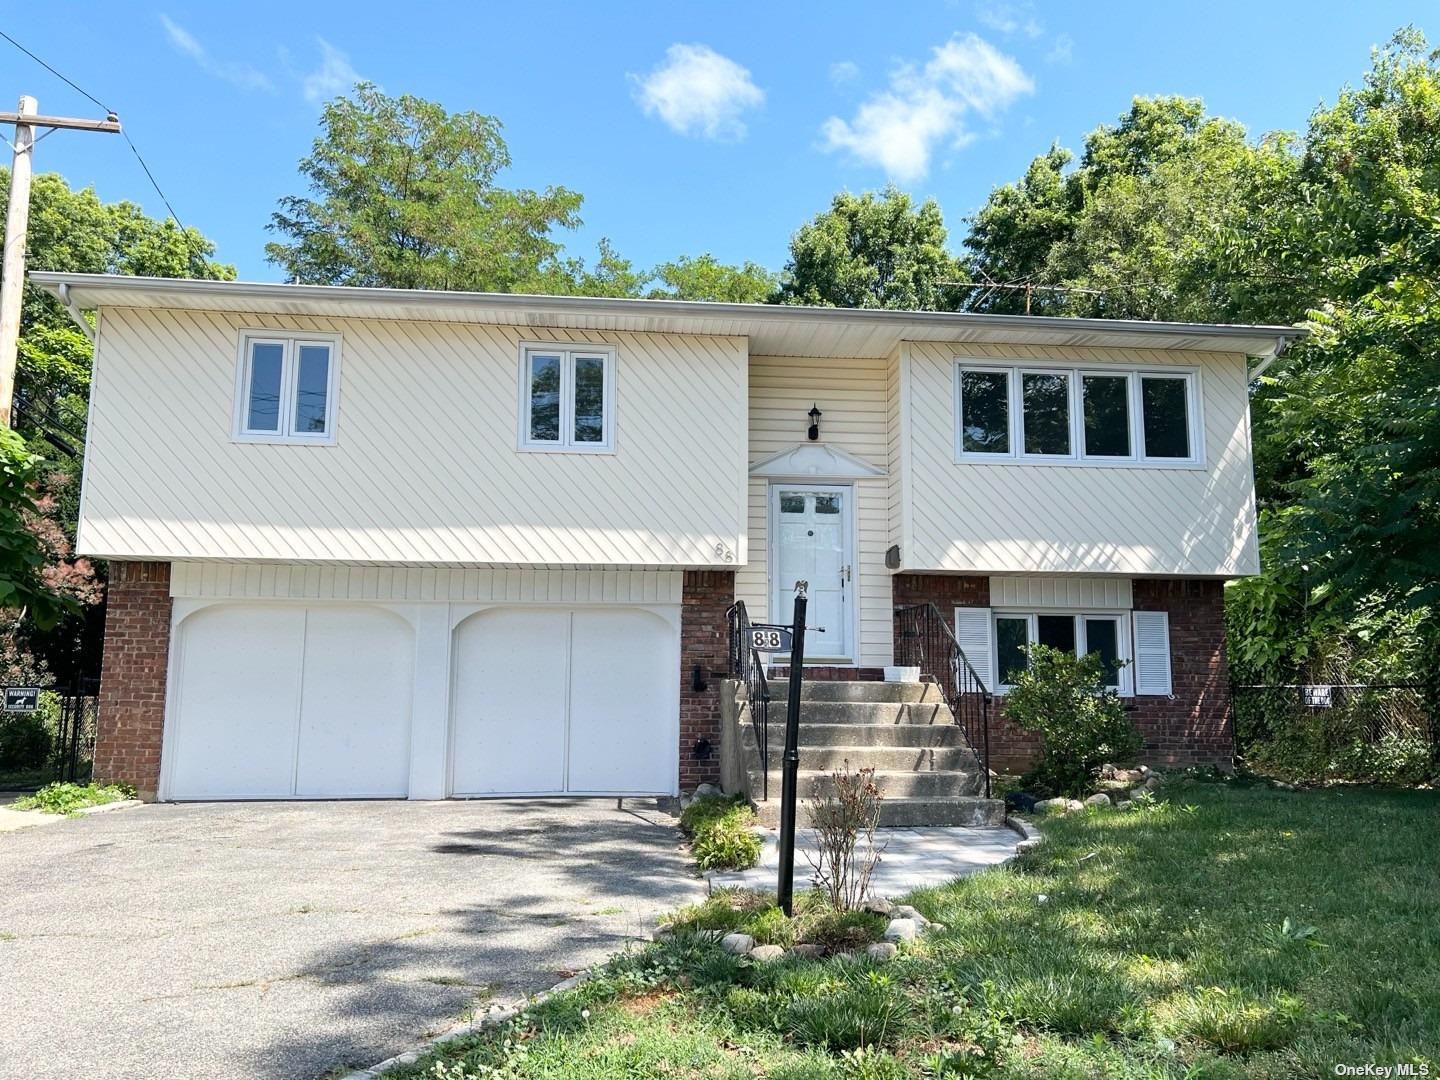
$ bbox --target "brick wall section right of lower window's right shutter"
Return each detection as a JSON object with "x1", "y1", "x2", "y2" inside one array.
[{"x1": 1129, "y1": 577, "x2": 1236, "y2": 769}]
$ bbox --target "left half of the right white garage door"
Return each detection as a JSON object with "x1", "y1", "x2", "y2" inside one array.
[{"x1": 451, "y1": 608, "x2": 570, "y2": 795}]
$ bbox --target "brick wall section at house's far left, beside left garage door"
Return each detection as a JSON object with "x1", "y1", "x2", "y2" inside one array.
[{"x1": 95, "y1": 562, "x2": 170, "y2": 799}]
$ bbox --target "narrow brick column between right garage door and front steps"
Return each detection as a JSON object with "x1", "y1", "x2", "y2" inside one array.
[{"x1": 680, "y1": 570, "x2": 734, "y2": 791}]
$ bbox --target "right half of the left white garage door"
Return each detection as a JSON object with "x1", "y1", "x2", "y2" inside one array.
[{"x1": 295, "y1": 608, "x2": 415, "y2": 798}]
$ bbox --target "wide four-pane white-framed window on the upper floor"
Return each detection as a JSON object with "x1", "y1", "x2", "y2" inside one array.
[{"x1": 955, "y1": 359, "x2": 1205, "y2": 468}]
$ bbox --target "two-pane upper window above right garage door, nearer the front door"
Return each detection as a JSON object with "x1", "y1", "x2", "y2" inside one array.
[{"x1": 520, "y1": 344, "x2": 615, "y2": 454}]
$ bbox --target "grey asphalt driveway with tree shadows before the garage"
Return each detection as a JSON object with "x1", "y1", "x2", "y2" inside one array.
[{"x1": 0, "y1": 799, "x2": 703, "y2": 1080}]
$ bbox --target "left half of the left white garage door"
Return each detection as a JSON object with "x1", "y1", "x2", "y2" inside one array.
[{"x1": 170, "y1": 606, "x2": 305, "y2": 799}]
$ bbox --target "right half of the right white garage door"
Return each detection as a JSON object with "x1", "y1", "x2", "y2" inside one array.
[{"x1": 569, "y1": 609, "x2": 678, "y2": 793}]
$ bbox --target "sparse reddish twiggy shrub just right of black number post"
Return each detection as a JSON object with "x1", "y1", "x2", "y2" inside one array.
[{"x1": 805, "y1": 762, "x2": 884, "y2": 912}]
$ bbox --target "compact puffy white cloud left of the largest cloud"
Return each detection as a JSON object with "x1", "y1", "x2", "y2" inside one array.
[{"x1": 631, "y1": 45, "x2": 765, "y2": 140}]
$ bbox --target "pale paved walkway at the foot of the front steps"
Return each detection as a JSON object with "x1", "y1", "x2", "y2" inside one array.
[{"x1": 710, "y1": 825, "x2": 1021, "y2": 897}]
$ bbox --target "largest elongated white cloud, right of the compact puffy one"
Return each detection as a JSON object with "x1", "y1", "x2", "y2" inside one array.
[{"x1": 821, "y1": 33, "x2": 1035, "y2": 183}]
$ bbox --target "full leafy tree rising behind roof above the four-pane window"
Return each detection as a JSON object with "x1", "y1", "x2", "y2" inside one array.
[{"x1": 965, "y1": 98, "x2": 1303, "y2": 321}]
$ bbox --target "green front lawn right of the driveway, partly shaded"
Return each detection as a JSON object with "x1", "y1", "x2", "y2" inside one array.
[{"x1": 395, "y1": 780, "x2": 1440, "y2": 1080}]
